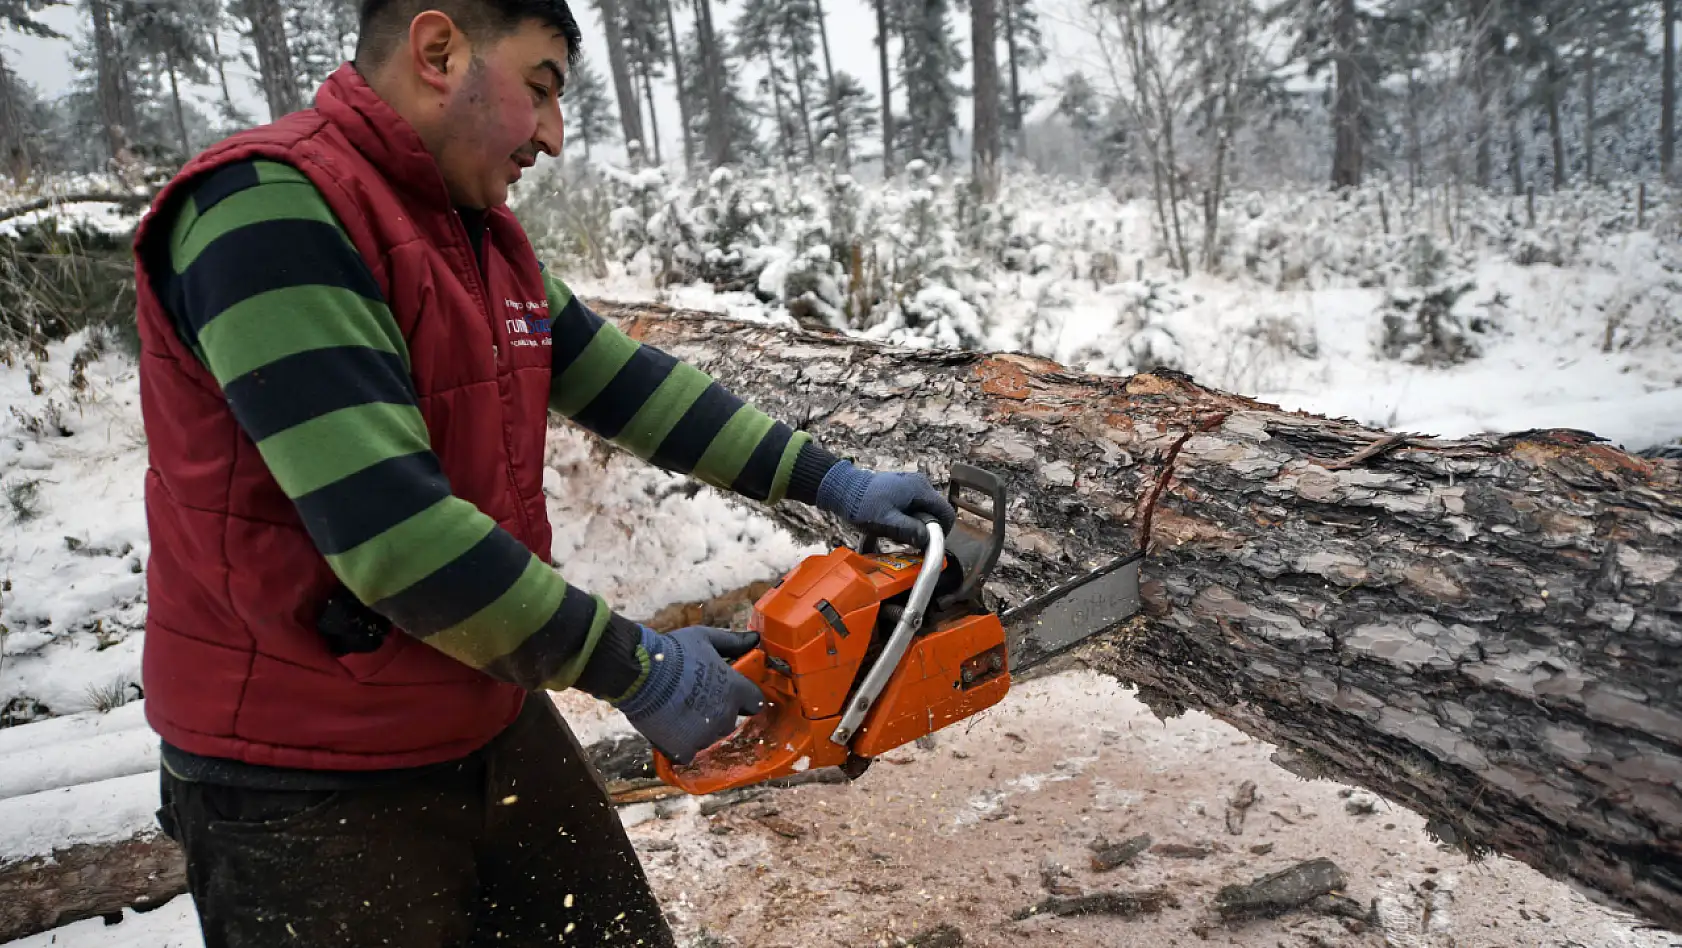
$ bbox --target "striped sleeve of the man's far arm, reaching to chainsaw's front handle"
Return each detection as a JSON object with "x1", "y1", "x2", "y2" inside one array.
[{"x1": 545, "y1": 274, "x2": 836, "y2": 504}]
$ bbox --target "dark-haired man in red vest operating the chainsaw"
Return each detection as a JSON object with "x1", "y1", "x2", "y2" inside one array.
[{"x1": 136, "y1": 0, "x2": 952, "y2": 948}]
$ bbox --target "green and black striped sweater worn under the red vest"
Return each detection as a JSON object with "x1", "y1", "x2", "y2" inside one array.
[{"x1": 160, "y1": 160, "x2": 836, "y2": 779}]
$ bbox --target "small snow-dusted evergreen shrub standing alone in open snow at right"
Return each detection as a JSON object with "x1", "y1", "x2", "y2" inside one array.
[{"x1": 1379, "y1": 234, "x2": 1502, "y2": 366}]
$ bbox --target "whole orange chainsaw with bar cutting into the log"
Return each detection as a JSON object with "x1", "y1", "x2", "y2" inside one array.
[{"x1": 654, "y1": 462, "x2": 1142, "y2": 795}]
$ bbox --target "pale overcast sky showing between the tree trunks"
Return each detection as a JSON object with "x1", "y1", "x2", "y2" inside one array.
[{"x1": 0, "y1": 0, "x2": 1123, "y2": 161}]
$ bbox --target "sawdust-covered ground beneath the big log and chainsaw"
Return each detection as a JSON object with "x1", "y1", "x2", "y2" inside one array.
[{"x1": 631, "y1": 671, "x2": 1682, "y2": 948}]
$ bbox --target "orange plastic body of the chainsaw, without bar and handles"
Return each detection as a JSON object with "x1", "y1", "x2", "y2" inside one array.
[{"x1": 654, "y1": 546, "x2": 1011, "y2": 793}]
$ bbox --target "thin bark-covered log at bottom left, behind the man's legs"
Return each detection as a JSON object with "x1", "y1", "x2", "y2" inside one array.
[{"x1": 0, "y1": 832, "x2": 187, "y2": 943}]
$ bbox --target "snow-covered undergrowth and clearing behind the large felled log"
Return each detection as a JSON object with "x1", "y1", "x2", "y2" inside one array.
[{"x1": 520, "y1": 165, "x2": 1682, "y2": 450}]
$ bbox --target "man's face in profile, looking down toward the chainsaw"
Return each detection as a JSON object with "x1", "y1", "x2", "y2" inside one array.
[{"x1": 436, "y1": 20, "x2": 567, "y2": 208}]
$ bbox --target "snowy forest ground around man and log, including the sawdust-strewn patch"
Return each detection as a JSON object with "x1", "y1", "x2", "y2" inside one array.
[{"x1": 0, "y1": 173, "x2": 1682, "y2": 948}]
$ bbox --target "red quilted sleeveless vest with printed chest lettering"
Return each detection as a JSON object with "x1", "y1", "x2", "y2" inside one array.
[{"x1": 135, "y1": 64, "x2": 552, "y2": 770}]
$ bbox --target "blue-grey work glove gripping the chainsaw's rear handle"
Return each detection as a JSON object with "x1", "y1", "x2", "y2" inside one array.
[{"x1": 619, "y1": 625, "x2": 765, "y2": 763}]
